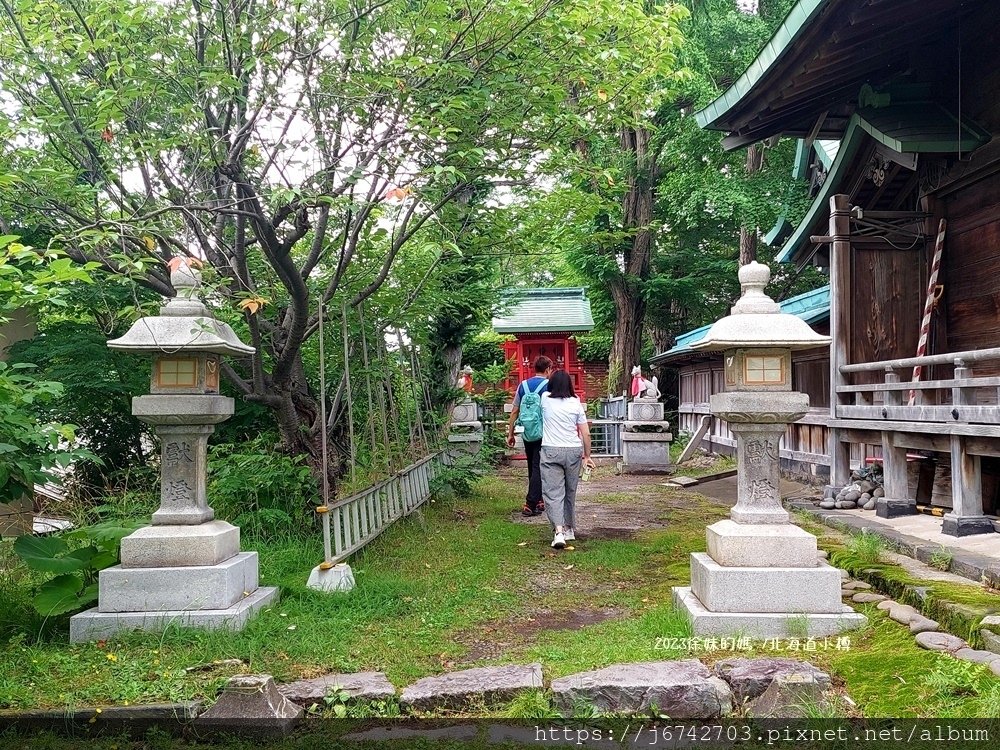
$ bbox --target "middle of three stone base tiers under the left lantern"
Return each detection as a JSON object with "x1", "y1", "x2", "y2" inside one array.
[{"x1": 97, "y1": 552, "x2": 257, "y2": 612}]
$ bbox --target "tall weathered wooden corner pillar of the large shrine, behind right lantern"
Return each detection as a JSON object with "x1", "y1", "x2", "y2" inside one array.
[{"x1": 828, "y1": 194, "x2": 851, "y2": 487}]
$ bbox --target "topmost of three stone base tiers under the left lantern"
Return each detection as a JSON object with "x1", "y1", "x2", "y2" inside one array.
[{"x1": 121, "y1": 521, "x2": 240, "y2": 568}]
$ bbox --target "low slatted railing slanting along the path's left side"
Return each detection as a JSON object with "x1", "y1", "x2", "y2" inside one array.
[{"x1": 327, "y1": 452, "x2": 446, "y2": 562}]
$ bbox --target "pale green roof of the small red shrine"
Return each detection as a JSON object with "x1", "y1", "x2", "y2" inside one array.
[{"x1": 493, "y1": 287, "x2": 594, "y2": 333}]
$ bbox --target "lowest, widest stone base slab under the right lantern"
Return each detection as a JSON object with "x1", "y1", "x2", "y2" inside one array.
[{"x1": 674, "y1": 586, "x2": 868, "y2": 639}]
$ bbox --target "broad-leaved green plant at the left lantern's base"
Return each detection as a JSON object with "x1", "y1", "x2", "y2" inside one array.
[{"x1": 14, "y1": 521, "x2": 144, "y2": 617}]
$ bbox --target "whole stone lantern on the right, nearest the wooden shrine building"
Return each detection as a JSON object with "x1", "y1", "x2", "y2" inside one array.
[{"x1": 674, "y1": 262, "x2": 865, "y2": 638}]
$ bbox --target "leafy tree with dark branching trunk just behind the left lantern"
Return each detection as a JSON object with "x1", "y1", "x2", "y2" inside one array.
[{"x1": 0, "y1": 0, "x2": 677, "y2": 488}]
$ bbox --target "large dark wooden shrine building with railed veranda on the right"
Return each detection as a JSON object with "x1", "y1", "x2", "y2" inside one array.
[{"x1": 697, "y1": 0, "x2": 1000, "y2": 536}]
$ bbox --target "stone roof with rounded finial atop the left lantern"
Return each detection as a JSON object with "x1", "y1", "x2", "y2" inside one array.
[{"x1": 108, "y1": 265, "x2": 255, "y2": 356}]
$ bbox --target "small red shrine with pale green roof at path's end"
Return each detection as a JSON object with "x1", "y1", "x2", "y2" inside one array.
[{"x1": 493, "y1": 287, "x2": 594, "y2": 401}]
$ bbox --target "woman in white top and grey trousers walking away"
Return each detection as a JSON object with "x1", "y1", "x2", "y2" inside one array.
[{"x1": 540, "y1": 370, "x2": 594, "y2": 549}]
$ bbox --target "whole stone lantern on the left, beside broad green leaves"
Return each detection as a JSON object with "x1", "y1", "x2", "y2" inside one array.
[{"x1": 70, "y1": 265, "x2": 277, "y2": 642}]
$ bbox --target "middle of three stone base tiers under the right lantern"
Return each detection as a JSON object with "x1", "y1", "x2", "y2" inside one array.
[{"x1": 691, "y1": 552, "x2": 844, "y2": 614}]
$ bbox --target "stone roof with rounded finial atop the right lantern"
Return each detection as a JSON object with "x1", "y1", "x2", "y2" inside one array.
[{"x1": 691, "y1": 261, "x2": 830, "y2": 352}]
